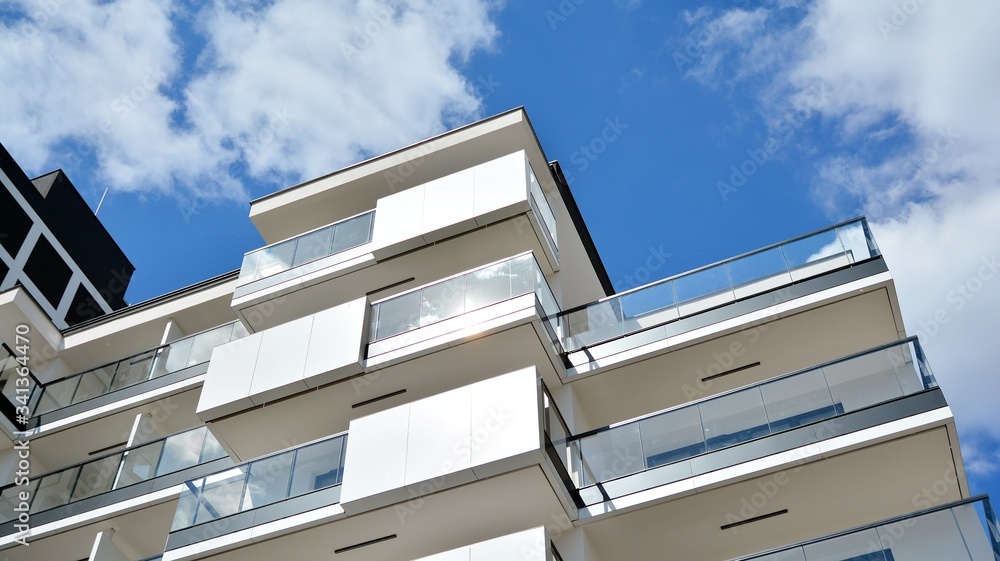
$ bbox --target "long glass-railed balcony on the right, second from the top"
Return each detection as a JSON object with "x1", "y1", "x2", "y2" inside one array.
[{"x1": 567, "y1": 338, "x2": 945, "y2": 505}]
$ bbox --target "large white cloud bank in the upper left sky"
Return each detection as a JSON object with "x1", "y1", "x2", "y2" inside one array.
[{"x1": 0, "y1": 0, "x2": 497, "y2": 206}]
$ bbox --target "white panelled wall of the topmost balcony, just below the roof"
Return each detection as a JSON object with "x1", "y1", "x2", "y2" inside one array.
[{"x1": 371, "y1": 150, "x2": 529, "y2": 259}]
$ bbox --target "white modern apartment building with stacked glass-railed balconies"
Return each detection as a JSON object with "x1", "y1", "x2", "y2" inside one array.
[{"x1": 0, "y1": 109, "x2": 1000, "y2": 561}]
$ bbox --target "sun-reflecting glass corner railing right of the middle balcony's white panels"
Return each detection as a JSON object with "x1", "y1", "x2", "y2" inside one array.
[{"x1": 369, "y1": 253, "x2": 559, "y2": 343}]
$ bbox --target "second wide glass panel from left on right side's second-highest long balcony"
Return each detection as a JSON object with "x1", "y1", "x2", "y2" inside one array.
[{"x1": 639, "y1": 407, "x2": 705, "y2": 469}]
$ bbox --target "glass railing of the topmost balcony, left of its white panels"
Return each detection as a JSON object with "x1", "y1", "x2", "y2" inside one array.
[{"x1": 236, "y1": 210, "x2": 375, "y2": 286}]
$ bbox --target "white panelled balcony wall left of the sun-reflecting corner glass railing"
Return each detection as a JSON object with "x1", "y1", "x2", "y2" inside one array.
[{"x1": 197, "y1": 298, "x2": 369, "y2": 422}]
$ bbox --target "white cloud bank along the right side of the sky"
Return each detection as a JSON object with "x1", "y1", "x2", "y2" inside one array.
[{"x1": 685, "y1": 0, "x2": 1000, "y2": 446}]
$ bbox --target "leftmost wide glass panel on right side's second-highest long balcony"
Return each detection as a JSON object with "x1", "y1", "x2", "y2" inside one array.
[{"x1": 579, "y1": 423, "x2": 644, "y2": 485}]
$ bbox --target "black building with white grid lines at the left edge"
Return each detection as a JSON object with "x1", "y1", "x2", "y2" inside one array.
[{"x1": 0, "y1": 139, "x2": 135, "y2": 312}]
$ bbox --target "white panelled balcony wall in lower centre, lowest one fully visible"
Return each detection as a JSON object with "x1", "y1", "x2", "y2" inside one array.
[{"x1": 340, "y1": 367, "x2": 543, "y2": 515}]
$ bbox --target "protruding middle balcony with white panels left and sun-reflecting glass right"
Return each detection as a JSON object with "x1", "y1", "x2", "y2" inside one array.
[{"x1": 197, "y1": 253, "x2": 560, "y2": 459}]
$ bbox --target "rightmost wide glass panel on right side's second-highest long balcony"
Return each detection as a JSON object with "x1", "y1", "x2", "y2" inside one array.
[{"x1": 823, "y1": 352, "x2": 903, "y2": 413}]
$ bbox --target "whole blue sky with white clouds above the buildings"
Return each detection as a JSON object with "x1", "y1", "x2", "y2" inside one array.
[{"x1": 0, "y1": 0, "x2": 1000, "y2": 506}]
